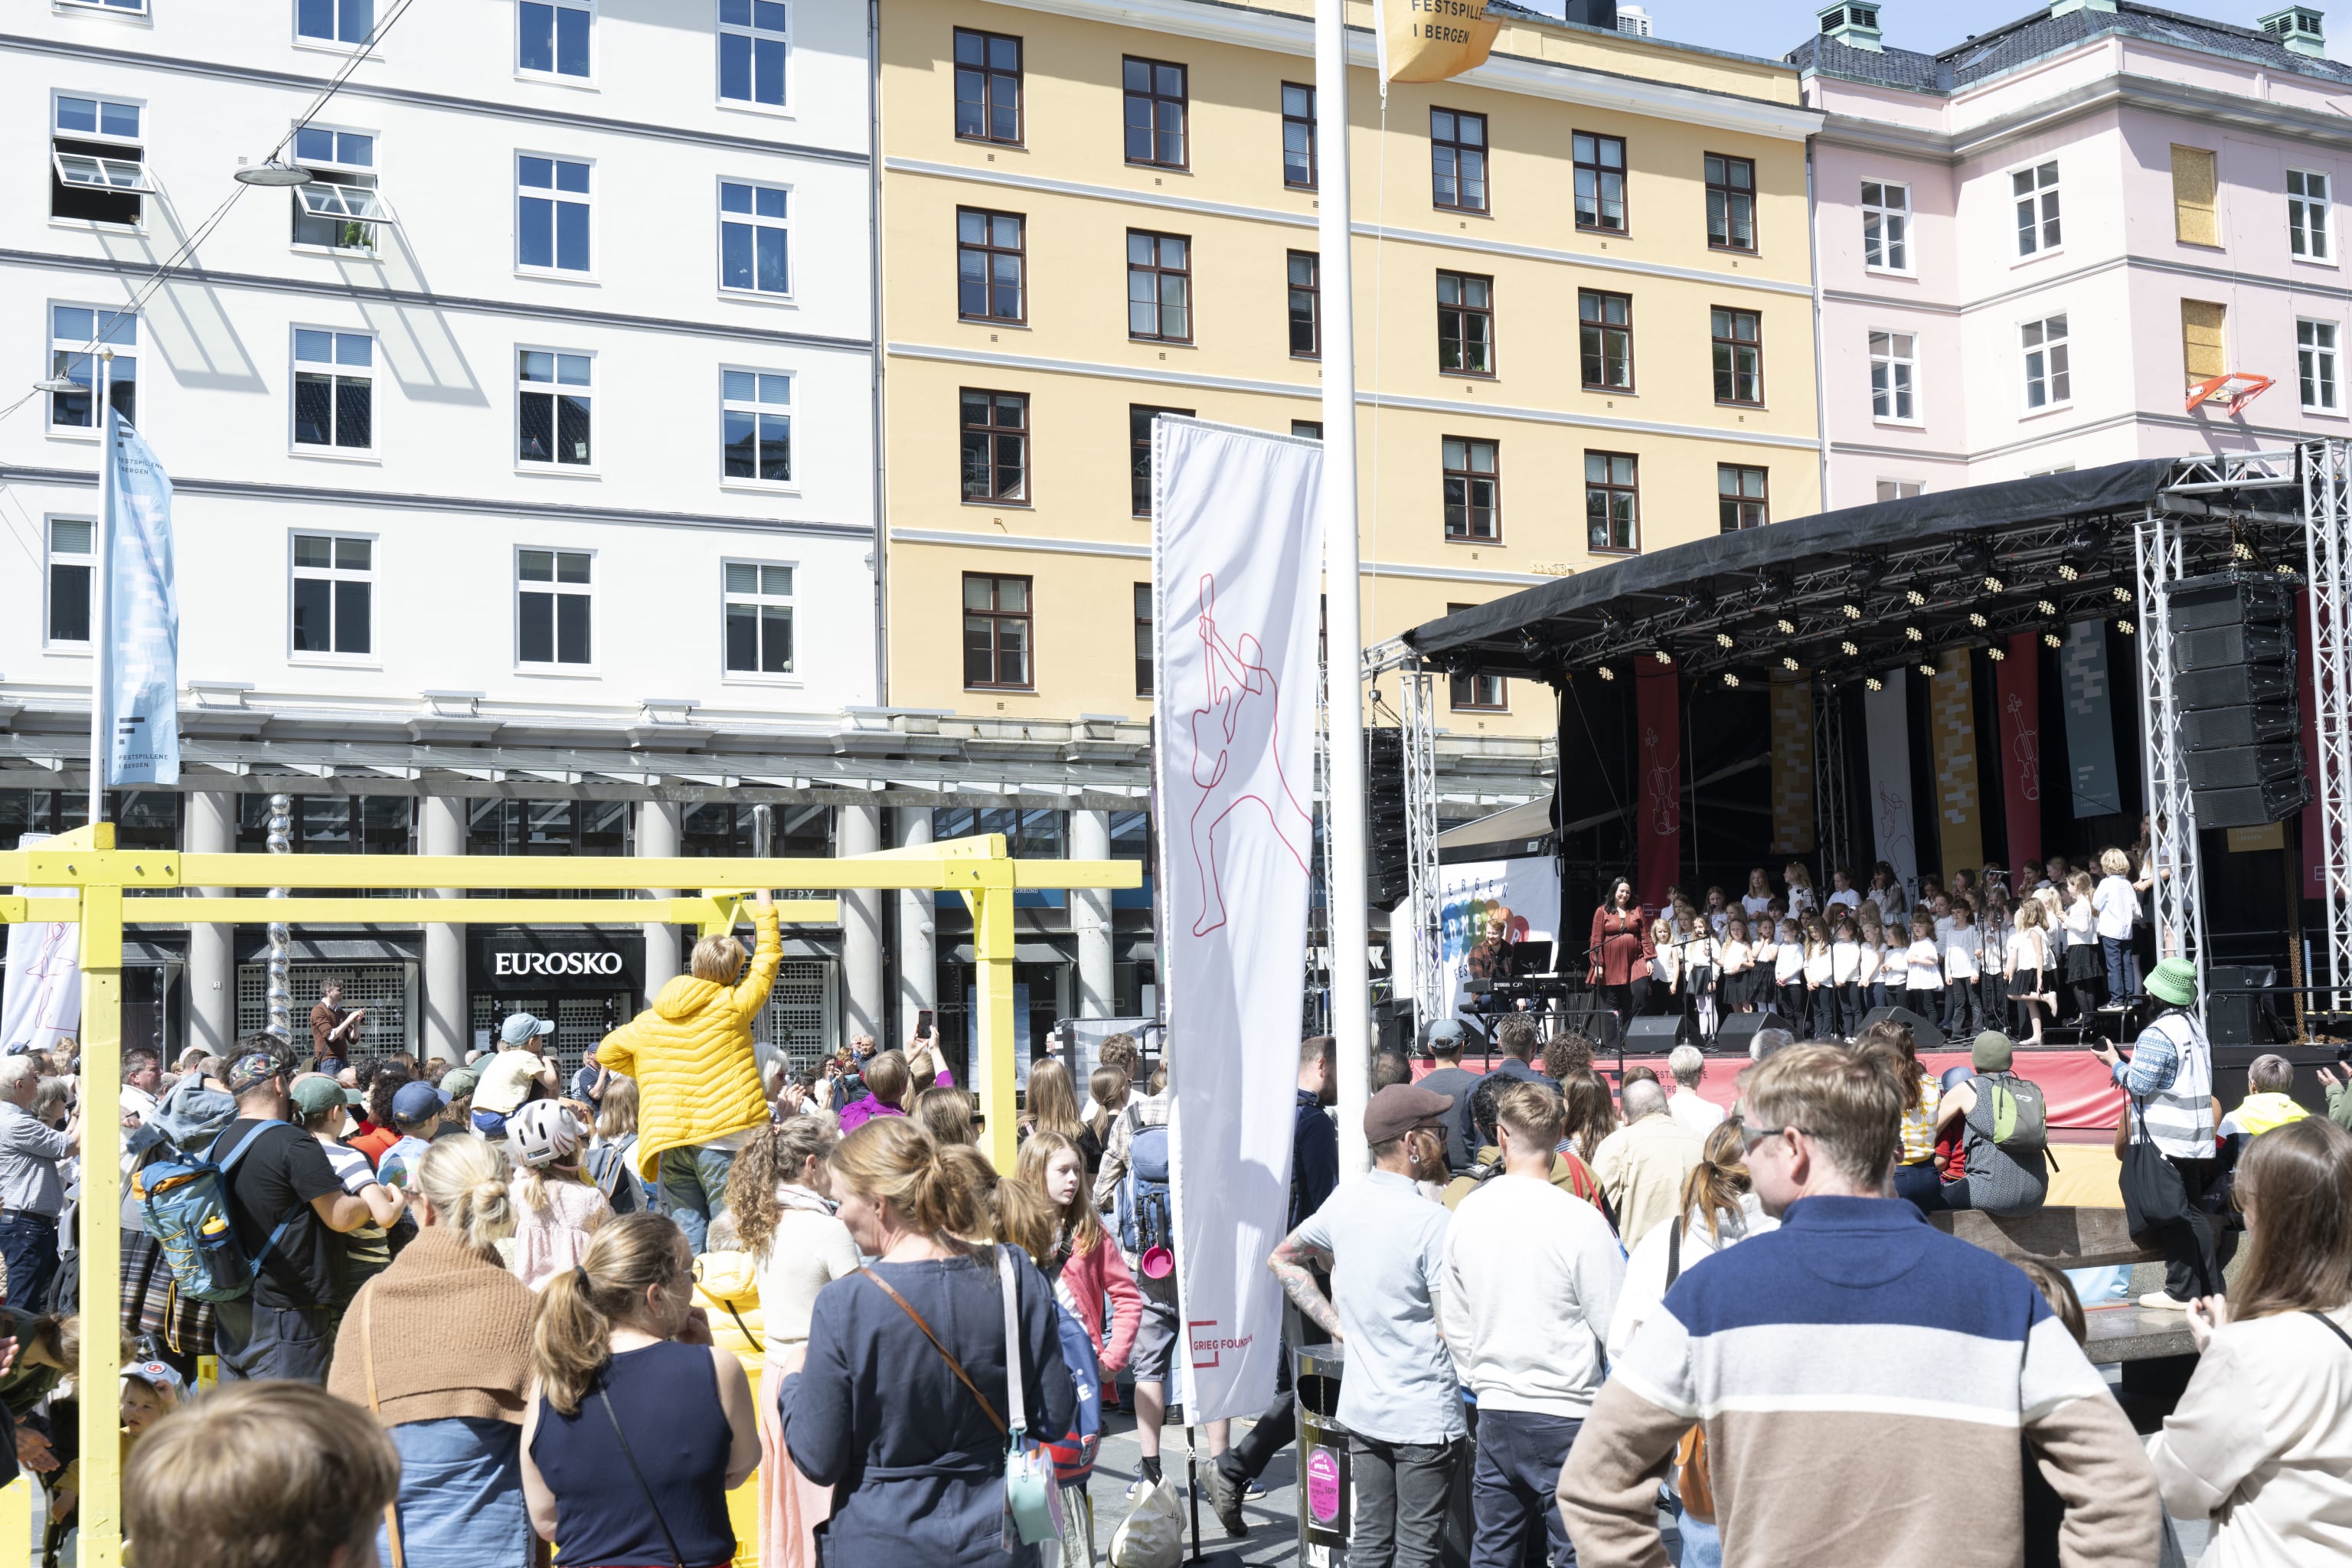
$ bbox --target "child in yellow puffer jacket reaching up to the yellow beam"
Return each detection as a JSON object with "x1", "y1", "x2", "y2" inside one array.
[{"x1": 588, "y1": 889, "x2": 783, "y2": 1253}]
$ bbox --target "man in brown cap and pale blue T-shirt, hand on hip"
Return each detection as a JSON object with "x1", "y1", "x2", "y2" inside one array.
[{"x1": 1268, "y1": 1083, "x2": 1463, "y2": 1568}]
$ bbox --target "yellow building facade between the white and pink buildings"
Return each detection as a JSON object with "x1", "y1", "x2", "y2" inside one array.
[{"x1": 880, "y1": 0, "x2": 1821, "y2": 736}]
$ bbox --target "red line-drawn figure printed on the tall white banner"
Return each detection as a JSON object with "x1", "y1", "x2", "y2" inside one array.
[{"x1": 1190, "y1": 576, "x2": 1315, "y2": 936}]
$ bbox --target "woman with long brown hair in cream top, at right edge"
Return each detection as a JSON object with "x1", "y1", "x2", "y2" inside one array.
[{"x1": 2148, "y1": 1116, "x2": 2352, "y2": 1568}]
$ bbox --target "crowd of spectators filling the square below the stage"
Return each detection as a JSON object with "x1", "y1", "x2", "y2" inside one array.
[{"x1": 0, "y1": 860, "x2": 2352, "y2": 1568}]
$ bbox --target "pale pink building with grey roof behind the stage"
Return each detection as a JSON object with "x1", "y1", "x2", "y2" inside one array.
[{"x1": 1788, "y1": 0, "x2": 2352, "y2": 508}]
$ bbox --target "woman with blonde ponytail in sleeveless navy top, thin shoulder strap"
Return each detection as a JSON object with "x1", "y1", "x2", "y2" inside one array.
[{"x1": 522, "y1": 1213, "x2": 760, "y2": 1568}]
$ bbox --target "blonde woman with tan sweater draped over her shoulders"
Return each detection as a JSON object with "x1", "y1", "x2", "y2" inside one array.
[{"x1": 327, "y1": 1138, "x2": 531, "y2": 1568}]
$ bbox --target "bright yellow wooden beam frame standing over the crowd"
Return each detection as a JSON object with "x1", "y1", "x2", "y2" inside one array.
[{"x1": 0, "y1": 823, "x2": 1143, "y2": 1568}]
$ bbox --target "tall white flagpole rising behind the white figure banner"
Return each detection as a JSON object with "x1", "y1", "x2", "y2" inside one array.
[{"x1": 1315, "y1": 0, "x2": 1371, "y2": 1178}]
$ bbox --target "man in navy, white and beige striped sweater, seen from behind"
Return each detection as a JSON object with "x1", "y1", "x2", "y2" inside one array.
[{"x1": 1560, "y1": 1046, "x2": 2157, "y2": 1568}]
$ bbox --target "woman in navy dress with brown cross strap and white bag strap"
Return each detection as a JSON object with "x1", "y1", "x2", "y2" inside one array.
[{"x1": 790, "y1": 1116, "x2": 1077, "y2": 1568}]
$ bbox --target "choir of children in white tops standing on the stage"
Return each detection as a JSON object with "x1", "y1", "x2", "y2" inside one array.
[{"x1": 1586, "y1": 841, "x2": 2154, "y2": 1046}]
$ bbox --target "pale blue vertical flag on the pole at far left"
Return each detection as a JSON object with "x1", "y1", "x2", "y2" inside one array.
[{"x1": 99, "y1": 409, "x2": 178, "y2": 788}]
